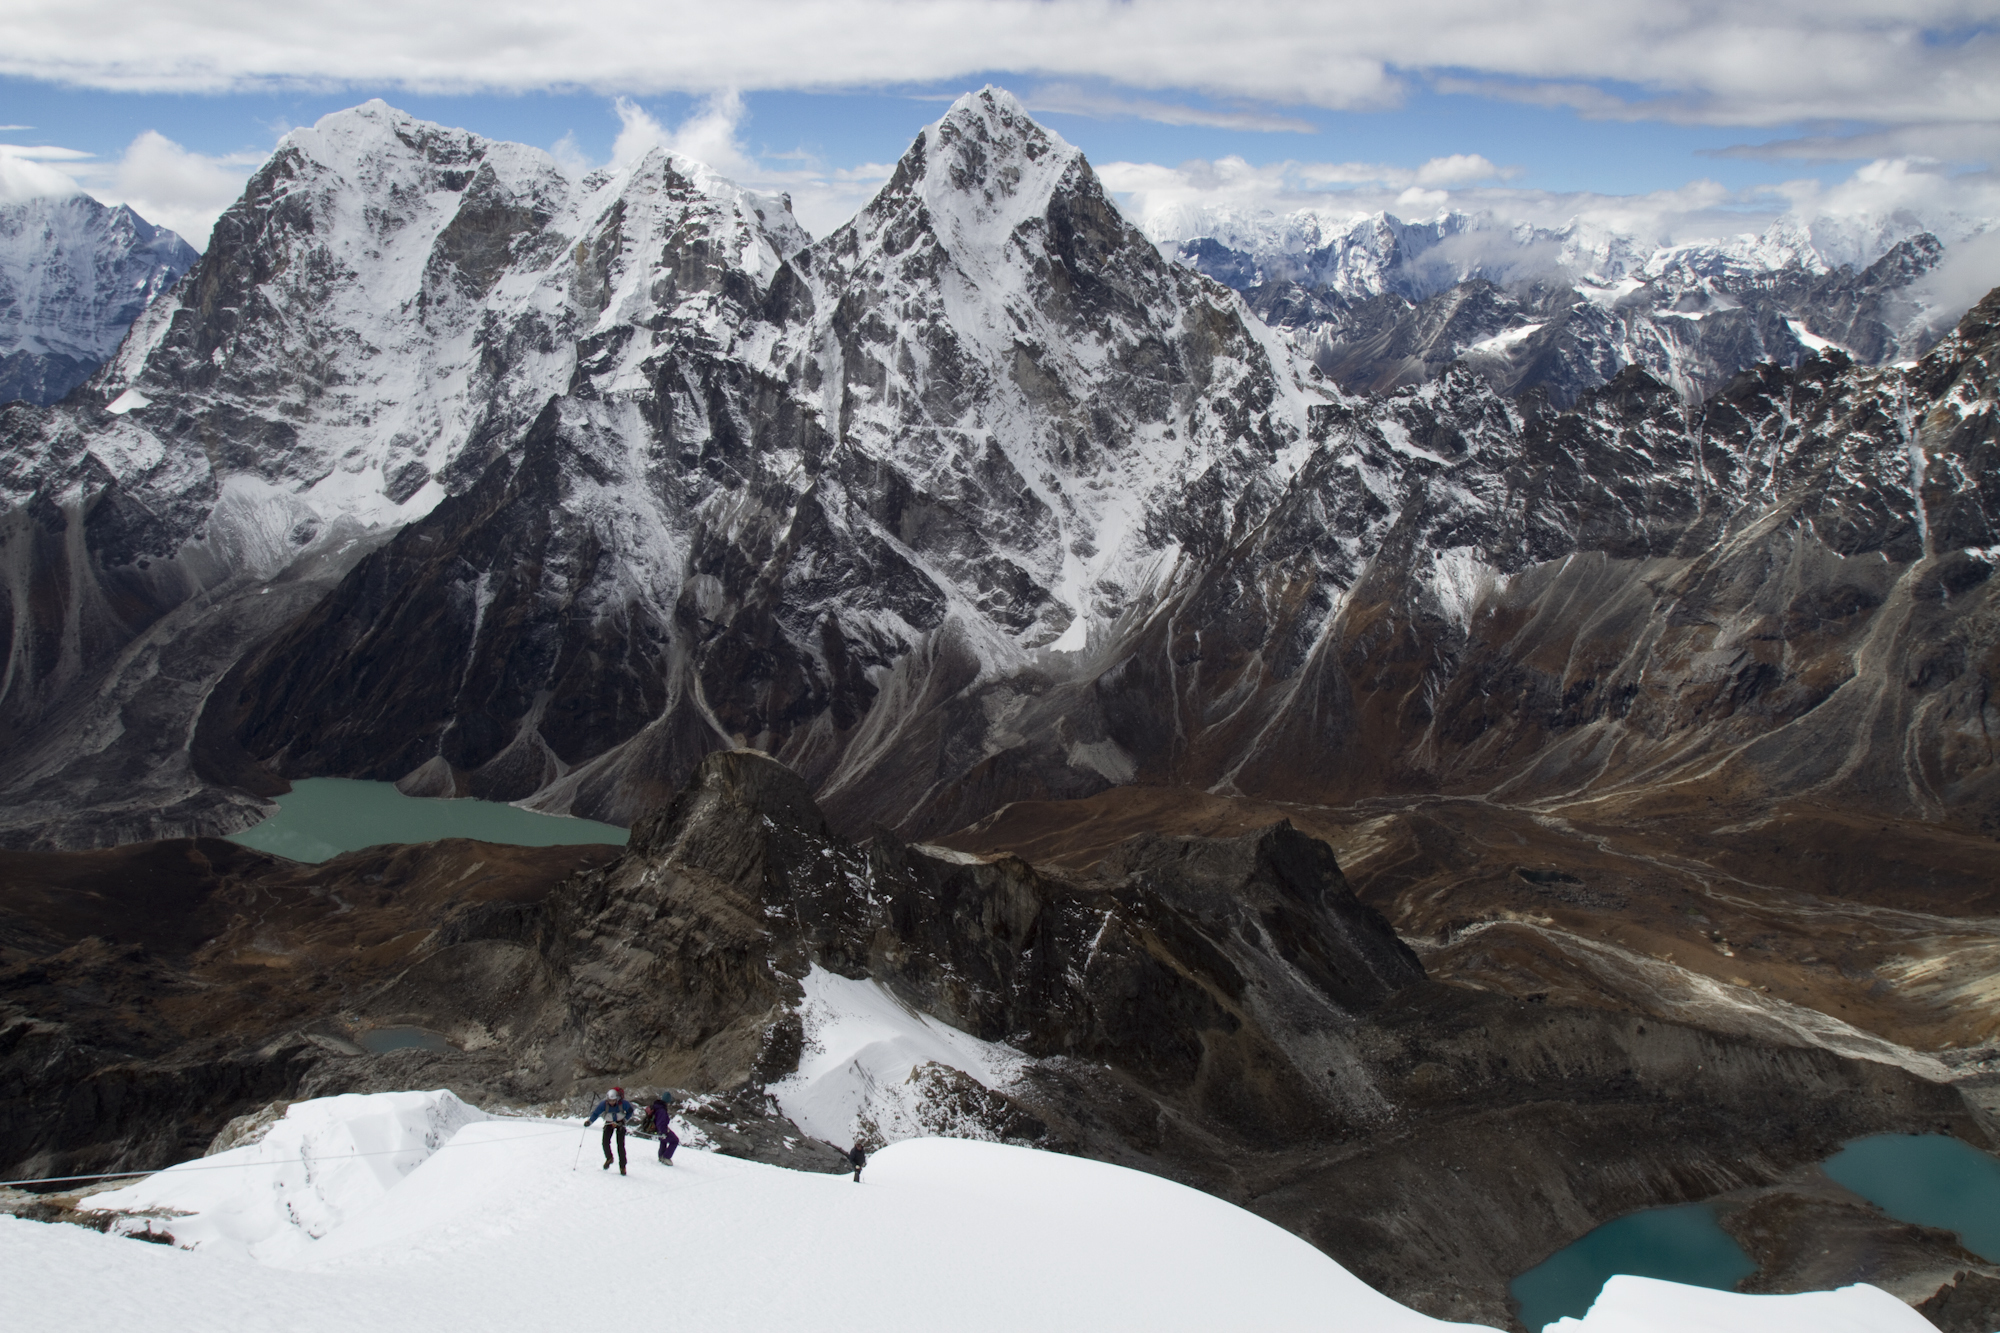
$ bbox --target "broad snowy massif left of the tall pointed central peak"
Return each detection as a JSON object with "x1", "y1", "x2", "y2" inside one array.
[{"x1": 60, "y1": 102, "x2": 804, "y2": 558}]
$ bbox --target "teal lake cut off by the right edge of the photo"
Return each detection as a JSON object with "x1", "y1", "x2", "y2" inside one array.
[{"x1": 1824, "y1": 1135, "x2": 2000, "y2": 1261}]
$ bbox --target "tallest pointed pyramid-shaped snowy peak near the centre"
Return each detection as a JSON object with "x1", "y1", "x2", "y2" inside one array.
[{"x1": 776, "y1": 88, "x2": 1336, "y2": 656}]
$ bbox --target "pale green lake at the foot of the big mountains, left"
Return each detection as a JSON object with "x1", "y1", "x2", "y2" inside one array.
[{"x1": 230, "y1": 779, "x2": 628, "y2": 861}]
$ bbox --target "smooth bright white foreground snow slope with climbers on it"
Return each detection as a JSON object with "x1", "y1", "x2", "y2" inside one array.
[{"x1": 0, "y1": 1093, "x2": 1928, "y2": 1333}]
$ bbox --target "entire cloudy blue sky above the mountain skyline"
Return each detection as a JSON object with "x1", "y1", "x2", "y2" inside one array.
[{"x1": 0, "y1": 0, "x2": 2000, "y2": 254}]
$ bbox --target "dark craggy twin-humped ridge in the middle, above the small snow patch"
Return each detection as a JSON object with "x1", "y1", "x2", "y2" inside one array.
[{"x1": 532, "y1": 753, "x2": 1422, "y2": 1139}]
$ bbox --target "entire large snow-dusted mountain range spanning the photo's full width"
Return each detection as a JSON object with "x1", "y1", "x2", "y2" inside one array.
[{"x1": 0, "y1": 90, "x2": 2000, "y2": 845}]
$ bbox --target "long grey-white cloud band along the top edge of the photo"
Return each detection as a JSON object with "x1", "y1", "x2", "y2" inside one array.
[{"x1": 0, "y1": 0, "x2": 2000, "y2": 137}]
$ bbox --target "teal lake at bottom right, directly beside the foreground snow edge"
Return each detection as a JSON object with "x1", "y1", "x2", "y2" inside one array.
[{"x1": 1508, "y1": 1203, "x2": 1756, "y2": 1329}]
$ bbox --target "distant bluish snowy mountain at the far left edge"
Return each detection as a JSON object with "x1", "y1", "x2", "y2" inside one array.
[{"x1": 0, "y1": 194, "x2": 200, "y2": 402}]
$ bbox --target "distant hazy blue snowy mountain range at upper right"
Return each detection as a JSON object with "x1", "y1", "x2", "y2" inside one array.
[{"x1": 1162, "y1": 212, "x2": 1944, "y2": 406}]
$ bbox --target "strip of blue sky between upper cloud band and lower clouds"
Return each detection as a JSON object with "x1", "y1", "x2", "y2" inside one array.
[{"x1": 0, "y1": 72, "x2": 1896, "y2": 194}]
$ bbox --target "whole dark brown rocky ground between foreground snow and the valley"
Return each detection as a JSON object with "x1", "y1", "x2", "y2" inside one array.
[{"x1": 0, "y1": 753, "x2": 1982, "y2": 1323}]
